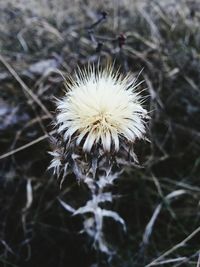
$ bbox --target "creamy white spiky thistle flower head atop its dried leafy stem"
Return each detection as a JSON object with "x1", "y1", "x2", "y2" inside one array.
[{"x1": 57, "y1": 67, "x2": 147, "y2": 153}]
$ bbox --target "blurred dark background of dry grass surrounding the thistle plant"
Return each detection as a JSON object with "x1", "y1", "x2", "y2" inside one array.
[{"x1": 0, "y1": 0, "x2": 200, "y2": 267}]
